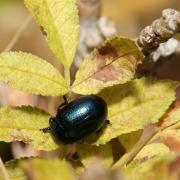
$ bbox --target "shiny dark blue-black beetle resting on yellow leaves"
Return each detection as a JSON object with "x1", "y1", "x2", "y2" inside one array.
[{"x1": 41, "y1": 95, "x2": 109, "y2": 144}]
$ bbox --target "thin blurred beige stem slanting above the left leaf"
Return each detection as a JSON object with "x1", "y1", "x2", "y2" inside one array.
[{"x1": 4, "y1": 15, "x2": 32, "y2": 52}]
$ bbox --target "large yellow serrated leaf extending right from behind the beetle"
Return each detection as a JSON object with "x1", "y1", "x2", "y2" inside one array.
[{"x1": 87, "y1": 78, "x2": 179, "y2": 145}]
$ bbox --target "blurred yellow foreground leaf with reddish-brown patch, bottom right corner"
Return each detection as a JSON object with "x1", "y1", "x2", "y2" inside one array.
[{"x1": 124, "y1": 156, "x2": 180, "y2": 180}]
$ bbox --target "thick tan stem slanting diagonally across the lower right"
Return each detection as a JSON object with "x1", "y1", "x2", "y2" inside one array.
[{"x1": 112, "y1": 128, "x2": 159, "y2": 169}]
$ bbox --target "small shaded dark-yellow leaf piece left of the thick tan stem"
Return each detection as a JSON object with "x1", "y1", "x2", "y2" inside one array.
[{"x1": 118, "y1": 130, "x2": 143, "y2": 151}]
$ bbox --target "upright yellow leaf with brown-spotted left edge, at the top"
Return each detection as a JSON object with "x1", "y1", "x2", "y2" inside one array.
[{"x1": 24, "y1": 0, "x2": 79, "y2": 67}]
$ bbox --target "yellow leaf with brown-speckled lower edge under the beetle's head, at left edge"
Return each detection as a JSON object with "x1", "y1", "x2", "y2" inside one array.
[{"x1": 0, "y1": 107, "x2": 58, "y2": 151}]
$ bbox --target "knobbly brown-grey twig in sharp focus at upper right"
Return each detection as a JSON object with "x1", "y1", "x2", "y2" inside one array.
[{"x1": 137, "y1": 9, "x2": 180, "y2": 55}]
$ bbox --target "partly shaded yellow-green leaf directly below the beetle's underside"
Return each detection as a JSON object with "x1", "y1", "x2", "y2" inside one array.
[{"x1": 77, "y1": 144, "x2": 113, "y2": 168}]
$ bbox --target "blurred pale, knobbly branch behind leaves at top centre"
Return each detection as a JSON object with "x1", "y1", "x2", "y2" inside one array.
[{"x1": 75, "y1": 0, "x2": 117, "y2": 67}]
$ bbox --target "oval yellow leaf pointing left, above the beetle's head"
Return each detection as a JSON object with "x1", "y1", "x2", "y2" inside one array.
[{"x1": 0, "y1": 52, "x2": 68, "y2": 96}]
